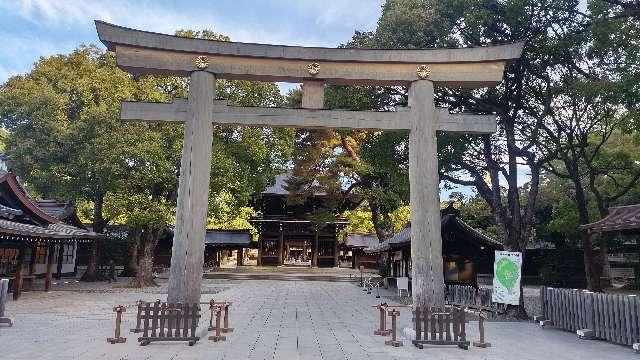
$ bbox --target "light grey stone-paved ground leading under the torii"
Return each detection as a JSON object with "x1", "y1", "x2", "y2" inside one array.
[{"x1": 0, "y1": 280, "x2": 638, "y2": 360}]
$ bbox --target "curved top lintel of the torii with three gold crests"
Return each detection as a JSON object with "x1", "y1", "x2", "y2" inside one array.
[{"x1": 95, "y1": 21, "x2": 523, "y2": 88}]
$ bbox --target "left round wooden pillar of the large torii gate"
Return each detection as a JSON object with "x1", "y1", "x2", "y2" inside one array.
[{"x1": 167, "y1": 71, "x2": 216, "y2": 303}]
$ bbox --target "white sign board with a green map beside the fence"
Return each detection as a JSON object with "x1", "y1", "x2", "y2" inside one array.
[{"x1": 491, "y1": 251, "x2": 522, "y2": 305}]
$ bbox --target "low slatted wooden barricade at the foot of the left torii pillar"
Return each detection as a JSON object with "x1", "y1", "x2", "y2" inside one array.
[{"x1": 138, "y1": 301, "x2": 200, "y2": 346}]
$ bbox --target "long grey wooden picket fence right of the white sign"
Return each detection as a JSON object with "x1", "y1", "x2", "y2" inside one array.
[{"x1": 540, "y1": 286, "x2": 640, "y2": 345}]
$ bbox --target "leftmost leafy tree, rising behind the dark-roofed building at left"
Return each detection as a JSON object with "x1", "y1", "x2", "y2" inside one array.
[{"x1": 0, "y1": 46, "x2": 166, "y2": 281}]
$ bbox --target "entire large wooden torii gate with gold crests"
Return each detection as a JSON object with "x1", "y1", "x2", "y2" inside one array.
[{"x1": 96, "y1": 21, "x2": 522, "y2": 306}]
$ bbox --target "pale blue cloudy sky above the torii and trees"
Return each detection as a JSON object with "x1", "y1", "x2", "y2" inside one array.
[{"x1": 0, "y1": 0, "x2": 526, "y2": 200}]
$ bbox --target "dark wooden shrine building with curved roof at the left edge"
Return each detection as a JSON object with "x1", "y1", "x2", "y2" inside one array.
[{"x1": 0, "y1": 172, "x2": 102, "y2": 299}]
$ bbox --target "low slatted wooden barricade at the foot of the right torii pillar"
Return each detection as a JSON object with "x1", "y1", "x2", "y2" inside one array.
[{"x1": 413, "y1": 307, "x2": 469, "y2": 350}]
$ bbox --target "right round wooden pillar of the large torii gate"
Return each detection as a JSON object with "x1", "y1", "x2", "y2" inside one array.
[{"x1": 409, "y1": 80, "x2": 444, "y2": 308}]
